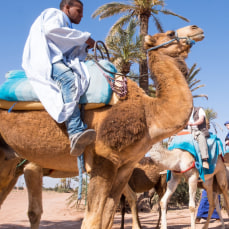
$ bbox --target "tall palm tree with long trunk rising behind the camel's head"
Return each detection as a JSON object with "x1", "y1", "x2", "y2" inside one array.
[{"x1": 92, "y1": 0, "x2": 189, "y2": 93}]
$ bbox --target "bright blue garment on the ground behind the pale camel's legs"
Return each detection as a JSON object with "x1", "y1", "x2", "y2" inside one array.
[{"x1": 196, "y1": 190, "x2": 220, "y2": 219}]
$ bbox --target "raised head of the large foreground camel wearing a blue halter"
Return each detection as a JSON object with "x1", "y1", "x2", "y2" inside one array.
[{"x1": 144, "y1": 25, "x2": 204, "y2": 58}]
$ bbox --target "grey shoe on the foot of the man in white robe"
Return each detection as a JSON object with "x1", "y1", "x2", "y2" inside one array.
[{"x1": 70, "y1": 129, "x2": 96, "y2": 156}]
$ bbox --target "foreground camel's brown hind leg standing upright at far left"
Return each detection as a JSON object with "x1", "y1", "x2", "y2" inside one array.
[{"x1": 24, "y1": 163, "x2": 43, "y2": 229}]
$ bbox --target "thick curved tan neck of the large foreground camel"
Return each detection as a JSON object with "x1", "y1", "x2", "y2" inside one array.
[{"x1": 146, "y1": 51, "x2": 192, "y2": 138}]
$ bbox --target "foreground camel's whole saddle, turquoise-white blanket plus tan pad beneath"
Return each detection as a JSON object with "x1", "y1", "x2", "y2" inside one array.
[{"x1": 0, "y1": 60, "x2": 121, "y2": 110}]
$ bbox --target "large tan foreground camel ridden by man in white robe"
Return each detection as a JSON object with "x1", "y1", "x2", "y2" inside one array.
[{"x1": 0, "y1": 25, "x2": 204, "y2": 229}]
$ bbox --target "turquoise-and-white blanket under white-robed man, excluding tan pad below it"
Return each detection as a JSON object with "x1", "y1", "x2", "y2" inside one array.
[{"x1": 0, "y1": 60, "x2": 117, "y2": 104}]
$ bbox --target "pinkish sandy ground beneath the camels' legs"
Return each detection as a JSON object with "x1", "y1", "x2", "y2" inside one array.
[{"x1": 0, "y1": 190, "x2": 229, "y2": 229}]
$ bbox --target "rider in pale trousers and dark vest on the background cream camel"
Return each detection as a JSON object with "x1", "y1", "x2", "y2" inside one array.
[{"x1": 188, "y1": 107, "x2": 210, "y2": 169}]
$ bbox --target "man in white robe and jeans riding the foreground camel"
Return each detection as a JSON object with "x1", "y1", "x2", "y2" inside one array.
[{"x1": 22, "y1": 0, "x2": 96, "y2": 156}]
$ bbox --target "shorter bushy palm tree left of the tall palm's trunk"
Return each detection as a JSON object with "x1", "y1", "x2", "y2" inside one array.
[{"x1": 106, "y1": 20, "x2": 142, "y2": 75}]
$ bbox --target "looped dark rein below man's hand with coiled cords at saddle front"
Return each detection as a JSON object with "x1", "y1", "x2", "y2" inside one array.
[{"x1": 93, "y1": 41, "x2": 127, "y2": 97}]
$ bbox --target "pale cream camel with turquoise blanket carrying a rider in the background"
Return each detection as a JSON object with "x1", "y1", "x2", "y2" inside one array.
[{"x1": 149, "y1": 143, "x2": 229, "y2": 229}]
